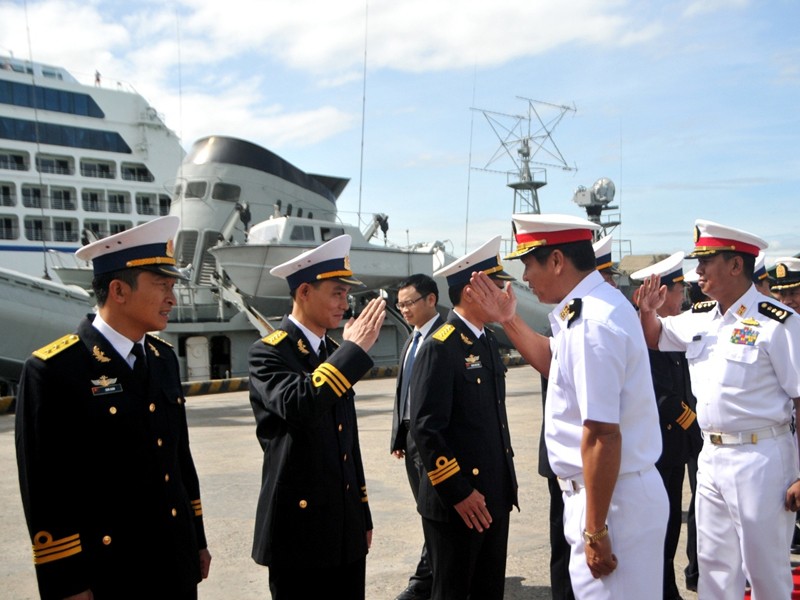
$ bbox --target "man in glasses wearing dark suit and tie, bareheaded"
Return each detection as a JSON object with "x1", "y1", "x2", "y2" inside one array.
[{"x1": 390, "y1": 273, "x2": 444, "y2": 600}]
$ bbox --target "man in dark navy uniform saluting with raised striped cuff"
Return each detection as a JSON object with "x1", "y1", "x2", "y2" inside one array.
[{"x1": 250, "y1": 235, "x2": 386, "y2": 600}]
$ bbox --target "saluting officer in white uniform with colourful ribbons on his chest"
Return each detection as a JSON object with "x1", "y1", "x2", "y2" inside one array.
[{"x1": 639, "y1": 220, "x2": 800, "y2": 600}]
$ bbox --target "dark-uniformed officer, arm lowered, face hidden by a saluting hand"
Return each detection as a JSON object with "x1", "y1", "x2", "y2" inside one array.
[{"x1": 411, "y1": 236, "x2": 517, "y2": 600}]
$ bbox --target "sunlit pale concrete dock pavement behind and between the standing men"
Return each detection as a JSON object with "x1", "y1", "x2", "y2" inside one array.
[{"x1": 0, "y1": 365, "x2": 697, "y2": 600}]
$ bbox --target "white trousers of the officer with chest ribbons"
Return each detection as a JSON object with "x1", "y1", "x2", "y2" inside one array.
[{"x1": 695, "y1": 433, "x2": 798, "y2": 600}]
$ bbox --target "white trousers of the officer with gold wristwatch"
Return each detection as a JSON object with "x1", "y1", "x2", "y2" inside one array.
[{"x1": 564, "y1": 468, "x2": 668, "y2": 600}]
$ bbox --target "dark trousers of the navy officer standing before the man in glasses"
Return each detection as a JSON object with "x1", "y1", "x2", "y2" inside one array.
[{"x1": 422, "y1": 512, "x2": 509, "y2": 600}]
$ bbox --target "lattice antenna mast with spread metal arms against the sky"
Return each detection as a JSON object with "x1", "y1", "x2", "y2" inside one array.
[{"x1": 472, "y1": 96, "x2": 578, "y2": 214}]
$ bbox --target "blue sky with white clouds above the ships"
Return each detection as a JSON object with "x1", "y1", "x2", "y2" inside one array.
[{"x1": 0, "y1": 0, "x2": 800, "y2": 266}]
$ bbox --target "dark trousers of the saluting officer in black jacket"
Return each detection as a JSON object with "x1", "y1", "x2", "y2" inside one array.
[{"x1": 270, "y1": 558, "x2": 367, "y2": 600}]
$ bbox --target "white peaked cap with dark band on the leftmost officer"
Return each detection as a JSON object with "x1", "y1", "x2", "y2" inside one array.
[{"x1": 75, "y1": 215, "x2": 186, "y2": 279}]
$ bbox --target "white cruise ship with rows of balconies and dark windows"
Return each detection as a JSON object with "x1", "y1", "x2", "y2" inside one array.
[{"x1": 0, "y1": 56, "x2": 185, "y2": 276}]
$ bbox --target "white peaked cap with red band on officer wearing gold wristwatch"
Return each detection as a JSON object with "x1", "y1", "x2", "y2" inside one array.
[{"x1": 506, "y1": 214, "x2": 600, "y2": 259}]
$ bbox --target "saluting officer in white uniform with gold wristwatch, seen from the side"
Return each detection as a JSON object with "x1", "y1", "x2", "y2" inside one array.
[{"x1": 468, "y1": 214, "x2": 669, "y2": 600}]
